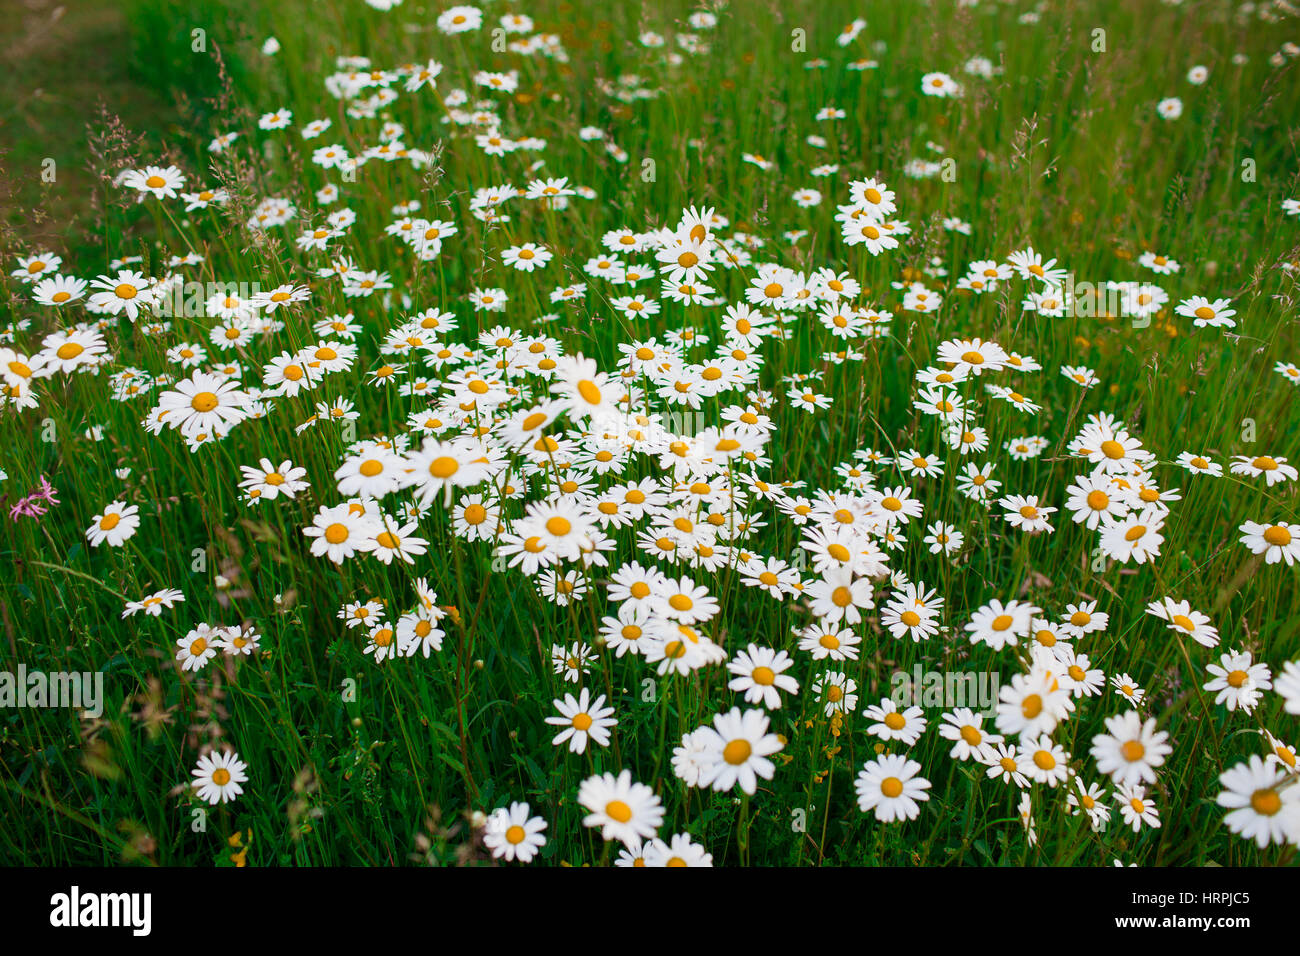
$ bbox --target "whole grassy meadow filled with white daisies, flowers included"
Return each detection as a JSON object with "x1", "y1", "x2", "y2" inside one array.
[{"x1": 0, "y1": 0, "x2": 1300, "y2": 866}]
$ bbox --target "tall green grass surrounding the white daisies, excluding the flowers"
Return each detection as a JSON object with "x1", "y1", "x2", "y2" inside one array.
[{"x1": 0, "y1": 0, "x2": 1300, "y2": 865}]
